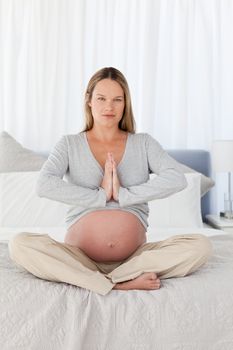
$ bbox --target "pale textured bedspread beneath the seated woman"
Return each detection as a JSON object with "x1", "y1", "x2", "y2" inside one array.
[{"x1": 0, "y1": 229, "x2": 233, "y2": 350}]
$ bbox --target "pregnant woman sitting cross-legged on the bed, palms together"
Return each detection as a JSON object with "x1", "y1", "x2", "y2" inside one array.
[{"x1": 9, "y1": 67, "x2": 212, "y2": 295}]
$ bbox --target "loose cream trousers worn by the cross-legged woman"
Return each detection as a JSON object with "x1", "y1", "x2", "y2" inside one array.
[{"x1": 9, "y1": 232, "x2": 212, "y2": 295}]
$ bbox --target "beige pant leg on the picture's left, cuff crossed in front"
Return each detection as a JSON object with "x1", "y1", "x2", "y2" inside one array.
[{"x1": 9, "y1": 232, "x2": 114, "y2": 295}]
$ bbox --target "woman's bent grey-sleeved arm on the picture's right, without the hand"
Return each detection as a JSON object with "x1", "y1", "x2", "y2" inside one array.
[{"x1": 118, "y1": 134, "x2": 187, "y2": 207}]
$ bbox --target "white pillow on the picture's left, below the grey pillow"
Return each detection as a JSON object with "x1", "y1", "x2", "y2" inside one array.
[{"x1": 0, "y1": 171, "x2": 69, "y2": 227}]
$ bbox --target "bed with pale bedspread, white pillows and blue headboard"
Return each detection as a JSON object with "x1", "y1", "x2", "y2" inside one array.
[{"x1": 0, "y1": 132, "x2": 233, "y2": 350}]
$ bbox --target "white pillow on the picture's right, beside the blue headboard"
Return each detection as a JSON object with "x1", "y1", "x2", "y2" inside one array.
[{"x1": 148, "y1": 173, "x2": 203, "y2": 232}]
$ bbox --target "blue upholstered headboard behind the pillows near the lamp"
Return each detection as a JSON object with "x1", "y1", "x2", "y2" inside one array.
[{"x1": 167, "y1": 149, "x2": 211, "y2": 220}]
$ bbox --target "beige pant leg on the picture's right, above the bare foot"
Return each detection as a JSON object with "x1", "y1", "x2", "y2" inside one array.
[{"x1": 108, "y1": 234, "x2": 212, "y2": 283}]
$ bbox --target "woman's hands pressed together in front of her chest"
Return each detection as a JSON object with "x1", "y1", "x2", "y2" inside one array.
[{"x1": 101, "y1": 152, "x2": 120, "y2": 202}]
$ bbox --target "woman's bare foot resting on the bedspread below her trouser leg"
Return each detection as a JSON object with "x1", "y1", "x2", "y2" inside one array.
[{"x1": 113, "y1": 272, "x2": 160, "y2": 290}]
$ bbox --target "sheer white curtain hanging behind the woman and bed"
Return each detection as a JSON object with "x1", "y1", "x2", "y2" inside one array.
[{"x1": 0, "y1": 0, "x2": 233, "y2": 212}]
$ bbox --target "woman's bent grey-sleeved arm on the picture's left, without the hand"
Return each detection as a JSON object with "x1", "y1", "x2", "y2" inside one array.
[{"x1": 36, "y1": 136, "x2": 106, "y2": 208}]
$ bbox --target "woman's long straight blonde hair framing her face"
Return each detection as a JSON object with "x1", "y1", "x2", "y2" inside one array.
[{"x1": 83, "y1": 67, "x2": 136, "y2": 133}]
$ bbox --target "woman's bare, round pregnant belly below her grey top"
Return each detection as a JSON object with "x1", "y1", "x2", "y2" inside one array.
[{"x1": 65, "y1": 210, "x2": 146, "y2": 262}]
